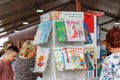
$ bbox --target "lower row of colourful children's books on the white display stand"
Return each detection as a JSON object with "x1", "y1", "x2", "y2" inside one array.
[{"x1": 35, "y1": 46, "x2": 95, "y2": 72}]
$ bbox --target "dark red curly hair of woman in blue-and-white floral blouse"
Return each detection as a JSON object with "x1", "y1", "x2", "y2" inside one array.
[{"x1": 106, "y1": 27, "x2": 120, "y2": 48}]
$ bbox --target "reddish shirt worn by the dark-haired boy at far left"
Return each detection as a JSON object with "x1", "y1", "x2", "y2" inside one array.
[{"x1": 0, "y1": 58, "x2": 13, "y2": 80}]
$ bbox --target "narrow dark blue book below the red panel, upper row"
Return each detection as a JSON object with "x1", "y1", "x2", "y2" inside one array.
[{"x1": 84, "y1": 23, "x2": 92, "y2": 44}]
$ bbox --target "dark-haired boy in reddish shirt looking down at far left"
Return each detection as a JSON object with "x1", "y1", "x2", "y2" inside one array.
[{"x1": 0, "y1": 45, "x2": 19, "y2": 80}]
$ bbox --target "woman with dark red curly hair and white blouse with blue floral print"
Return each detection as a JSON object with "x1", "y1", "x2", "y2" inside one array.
[{"x1": 100, "y1": 27, "x2": 120, "y2": 80}]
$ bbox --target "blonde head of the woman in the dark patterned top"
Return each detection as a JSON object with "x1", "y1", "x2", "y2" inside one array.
[{"x1": 20, "y1": 40, "x2": 34, "y2": 57}]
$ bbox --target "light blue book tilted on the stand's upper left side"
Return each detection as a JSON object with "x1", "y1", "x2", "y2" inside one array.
[{"x1": 34, "y1": 20, "x2": 52, "y2": 44}]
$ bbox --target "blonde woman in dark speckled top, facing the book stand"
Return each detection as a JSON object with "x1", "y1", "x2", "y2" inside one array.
[{"x1": 14, "y1": 41, "x2": 37, "y2": 80}]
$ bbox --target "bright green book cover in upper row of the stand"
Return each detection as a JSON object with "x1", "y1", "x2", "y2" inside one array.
[{"x1": 55, "y1": 21, "x2": 66, "y2": 42}]
